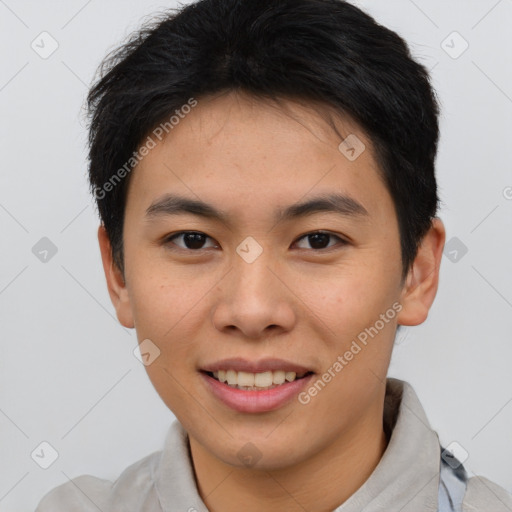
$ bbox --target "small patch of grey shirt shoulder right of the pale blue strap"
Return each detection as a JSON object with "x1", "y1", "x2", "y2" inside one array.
[{"x1": 462, "y1": 476, "x2": 512, "y2": 512}]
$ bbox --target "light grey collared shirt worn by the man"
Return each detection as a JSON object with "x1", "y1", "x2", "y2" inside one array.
[{"x1": 36, "y1": 378, "x2": 512, "y2": 512}]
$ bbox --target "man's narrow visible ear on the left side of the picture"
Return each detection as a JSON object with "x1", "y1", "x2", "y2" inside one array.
[{"x1": 98, "y1": 224, "x2": 135, "y2": 328}]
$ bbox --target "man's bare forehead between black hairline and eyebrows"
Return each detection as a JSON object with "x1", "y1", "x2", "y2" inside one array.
[{"x1": 128, "y1": 93, "x2": 392, "y2": 222}]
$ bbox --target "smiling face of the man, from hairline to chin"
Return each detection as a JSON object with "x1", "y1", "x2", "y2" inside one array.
[{"x1": 99, "y1": 93, "x2": 440, "y2": 469}]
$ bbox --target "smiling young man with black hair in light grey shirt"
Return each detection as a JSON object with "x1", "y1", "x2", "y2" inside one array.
[{"x1": 38, "y1": 0, "x2": 512, "y2": 512}]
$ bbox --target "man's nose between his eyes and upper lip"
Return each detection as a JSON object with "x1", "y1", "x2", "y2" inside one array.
[{"x1": 211, "y1": 251, "x2": 297, "y2": 339}]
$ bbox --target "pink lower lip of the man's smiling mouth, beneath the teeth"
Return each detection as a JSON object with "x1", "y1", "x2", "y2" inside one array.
[{"x1": 200, "y1": 372, "x2": 314, "y2": 413}]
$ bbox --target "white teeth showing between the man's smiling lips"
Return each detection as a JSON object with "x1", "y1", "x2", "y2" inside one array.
[{"x1": 204, "y1": 370, "x2": 313, "y2": 391}]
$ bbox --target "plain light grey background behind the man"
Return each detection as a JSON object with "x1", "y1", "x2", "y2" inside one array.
[{"x1": 0, "y1": 0, "x2": 512, "y2": 512}]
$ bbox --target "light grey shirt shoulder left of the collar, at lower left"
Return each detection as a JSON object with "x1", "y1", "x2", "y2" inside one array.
[{"x1": 35, "y1": 452, "x2": 161, "y2": 512}]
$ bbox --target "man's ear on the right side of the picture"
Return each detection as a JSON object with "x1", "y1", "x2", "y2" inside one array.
[{"x1": 397, "y1": 218, "x2": 446, "y2": 325}]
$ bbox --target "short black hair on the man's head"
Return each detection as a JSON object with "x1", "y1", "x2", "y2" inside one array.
[{"x1": 87, "y1": 0, "x2": 439, "y2": 277}]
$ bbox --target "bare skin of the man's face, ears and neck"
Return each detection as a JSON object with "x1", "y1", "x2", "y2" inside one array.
[{"x1": 98, "y1": 93, "x2": 445, "y2": 512}]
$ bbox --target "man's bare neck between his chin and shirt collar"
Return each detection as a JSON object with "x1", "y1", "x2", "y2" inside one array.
[{"x1": 190, "y1": 405, "x2": 387, "y2": 512}]
